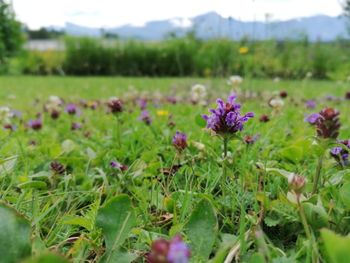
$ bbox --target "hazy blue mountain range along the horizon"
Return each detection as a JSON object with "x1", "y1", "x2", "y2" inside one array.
[{"x1": 63, "y1": 12, "x2": 349, "y2": 41}]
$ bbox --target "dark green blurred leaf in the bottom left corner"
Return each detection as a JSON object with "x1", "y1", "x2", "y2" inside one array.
[{"x1": 0, "y1": 204, "x2": 32, "y2": 263}]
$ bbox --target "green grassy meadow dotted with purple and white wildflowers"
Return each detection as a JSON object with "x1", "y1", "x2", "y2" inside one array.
[{"x1": 0, "y1": 76, "x2": 350, "y2": 263}]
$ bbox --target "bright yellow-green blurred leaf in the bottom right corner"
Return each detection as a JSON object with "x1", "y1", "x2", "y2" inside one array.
[{"x1": 321, "y1": 229, "x2": 350, "y2": 263}]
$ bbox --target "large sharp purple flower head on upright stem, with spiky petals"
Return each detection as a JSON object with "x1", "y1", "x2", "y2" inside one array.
[{"x1": 202, "y1": 95, "x2": 254, "y2": 135}]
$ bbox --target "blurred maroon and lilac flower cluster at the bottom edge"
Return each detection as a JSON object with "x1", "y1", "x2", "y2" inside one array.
[{"x1": 146, "y1": 236, "x2": 191, "y2": 263}]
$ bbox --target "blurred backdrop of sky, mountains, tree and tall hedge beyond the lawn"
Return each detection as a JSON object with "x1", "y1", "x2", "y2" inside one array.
[{"x1": 0, "y1": 0, "x2": 350, "y2": 80}]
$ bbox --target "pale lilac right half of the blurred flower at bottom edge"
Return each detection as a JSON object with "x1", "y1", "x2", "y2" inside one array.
[{"x1": 167, "y1": 235, "x2": 191, "y2": 263}]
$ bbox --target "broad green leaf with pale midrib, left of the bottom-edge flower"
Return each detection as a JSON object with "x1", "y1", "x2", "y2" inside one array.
[{"x1": 96, "y1": 195, "x2": 136, "y2": 262}]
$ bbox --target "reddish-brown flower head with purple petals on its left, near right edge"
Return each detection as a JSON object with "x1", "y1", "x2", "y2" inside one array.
[{"x1": 305, "y1": 108, "x2": 340, "y2": 139}]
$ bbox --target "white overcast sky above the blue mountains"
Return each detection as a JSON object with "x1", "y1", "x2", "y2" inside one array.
[{"x1": 12, "y1": 0, "x2": 343, "y2": 28}]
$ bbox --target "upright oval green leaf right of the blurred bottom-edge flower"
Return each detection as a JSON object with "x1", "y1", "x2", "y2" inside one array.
[{"x1": 185, "y1": 198, "x2": 218, "y2": 262}]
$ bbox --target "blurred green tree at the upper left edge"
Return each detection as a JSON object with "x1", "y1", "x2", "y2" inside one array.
[{"x1": 0, "y1": 0, "x2": 23, "y2": 67}]
